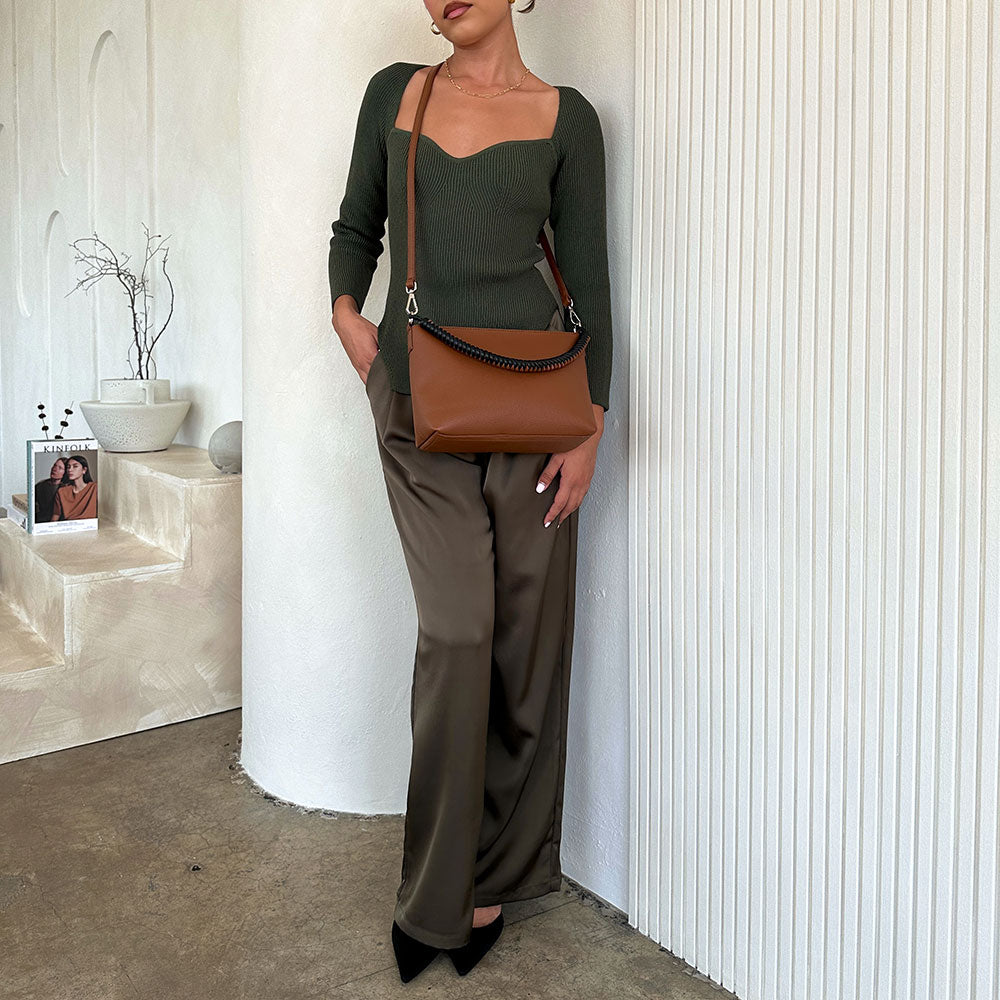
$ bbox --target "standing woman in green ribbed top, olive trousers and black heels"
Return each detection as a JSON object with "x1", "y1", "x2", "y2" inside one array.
[{"x1": 329, "y1": 0, "x2": 612, "y2": 982}]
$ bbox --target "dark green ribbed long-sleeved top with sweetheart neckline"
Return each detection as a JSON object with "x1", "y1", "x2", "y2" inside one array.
[{"x1": 329, "y1": 62, "x2": 612, "y2": 410}]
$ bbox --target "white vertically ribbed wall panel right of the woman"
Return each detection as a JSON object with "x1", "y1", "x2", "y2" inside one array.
[{"x1": 629, "y1": 0, "x2": 1000, "y2": 1000}]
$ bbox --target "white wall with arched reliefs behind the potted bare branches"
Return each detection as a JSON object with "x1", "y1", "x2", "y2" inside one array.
[{"x1": 0, "y1": 0, "x2": 242, "y2": 505}]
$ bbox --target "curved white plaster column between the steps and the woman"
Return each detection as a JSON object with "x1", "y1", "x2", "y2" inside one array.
[{"x1": 239, "y1": 0, "x2": 416, "y2": 813}]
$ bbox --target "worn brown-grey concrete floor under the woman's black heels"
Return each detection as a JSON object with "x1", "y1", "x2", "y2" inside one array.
[{"x1": 0, "y1": 710, "x2": 732, "y2": 1000}]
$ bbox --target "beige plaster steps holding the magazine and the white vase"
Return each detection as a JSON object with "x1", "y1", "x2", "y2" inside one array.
[{"x1": 0, "y1": 445, "x2": 243, "y2": 764}]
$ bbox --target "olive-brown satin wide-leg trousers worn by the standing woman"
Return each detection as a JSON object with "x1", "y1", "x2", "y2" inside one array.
[{"x1": 365, "y1": 310, "x2": 579, "y2": 948}]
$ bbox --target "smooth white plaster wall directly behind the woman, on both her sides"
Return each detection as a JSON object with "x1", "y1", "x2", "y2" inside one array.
[{"x1": 240, "y1": 0, "x2": 633, "y2": 908}]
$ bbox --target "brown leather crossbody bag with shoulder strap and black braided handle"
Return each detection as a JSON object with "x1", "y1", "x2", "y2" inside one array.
[{"x1": 405, "y1": 62, "x2": 597, "y2": 453}]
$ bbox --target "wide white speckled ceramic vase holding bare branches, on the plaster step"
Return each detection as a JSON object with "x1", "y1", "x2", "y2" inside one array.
[{"x1": 80, "y1": 378, "x2": 191, "y2": 451}]
